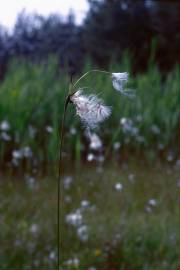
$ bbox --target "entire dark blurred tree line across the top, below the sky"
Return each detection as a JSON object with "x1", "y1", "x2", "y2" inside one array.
[{"x1": 0, "y1": 0, "x2": 180, "y2": 78}]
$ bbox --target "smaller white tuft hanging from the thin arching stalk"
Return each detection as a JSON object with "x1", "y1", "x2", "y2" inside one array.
[{"x1": 112, "y1": 72, "x2": 135, "y2": 98}]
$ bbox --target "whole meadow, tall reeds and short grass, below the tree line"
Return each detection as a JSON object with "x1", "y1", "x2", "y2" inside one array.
[{"x1": 0, "y1": 56, "x2": 180, "y2": 270}]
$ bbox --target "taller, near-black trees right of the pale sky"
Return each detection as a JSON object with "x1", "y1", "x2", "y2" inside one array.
[{"x1": 84, "y1": 0, "x2": 180, "y2": 70}]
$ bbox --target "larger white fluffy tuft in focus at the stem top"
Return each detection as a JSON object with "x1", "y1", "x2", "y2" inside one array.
[{"x1": 70, "y1": 89, "x2": 111, "y2": 129}]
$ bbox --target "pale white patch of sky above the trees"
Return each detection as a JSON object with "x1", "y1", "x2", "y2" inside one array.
[{"x1": 0, "y1": 0, "x2": 88, "y2": 29}]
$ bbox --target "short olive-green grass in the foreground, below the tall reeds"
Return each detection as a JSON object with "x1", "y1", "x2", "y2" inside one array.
[{"x1": 0, "y1": 164, "x2": 180, "y2": 270}]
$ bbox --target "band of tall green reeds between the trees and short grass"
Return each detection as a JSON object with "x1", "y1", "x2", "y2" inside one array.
[{"x1": 0, "y1": 56, "x2": 180, "y2": 167}]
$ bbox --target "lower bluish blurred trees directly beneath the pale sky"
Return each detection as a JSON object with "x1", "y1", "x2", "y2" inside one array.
[{"x1": 0, "y1": 13, "x2": 84, "y2": 78}]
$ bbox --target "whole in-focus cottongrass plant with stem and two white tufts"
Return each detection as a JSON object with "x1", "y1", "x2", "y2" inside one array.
[{"x1": 57, "y1": 70, "x2": 134, "y2": 269}]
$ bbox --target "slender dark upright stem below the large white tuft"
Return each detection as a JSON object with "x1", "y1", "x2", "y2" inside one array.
[{"x1": 57, "y1": 96, "x2": 70, "y2": 270}]
